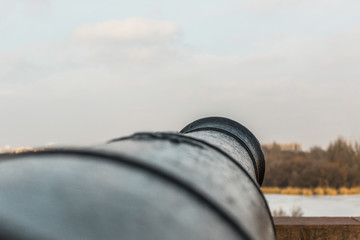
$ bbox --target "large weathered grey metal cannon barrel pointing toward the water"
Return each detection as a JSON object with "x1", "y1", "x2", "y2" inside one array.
[{"x1": 0, "y1": 117, "x2": 275, "y2": 240}]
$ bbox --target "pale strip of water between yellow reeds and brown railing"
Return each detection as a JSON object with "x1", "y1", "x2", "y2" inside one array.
[{"x1": 265, "y1": 194, "x2": 360, "y2": 217}]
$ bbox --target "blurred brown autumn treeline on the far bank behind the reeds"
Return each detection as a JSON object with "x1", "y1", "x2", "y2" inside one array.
[{"x1": 263, "y1": 138, "x2": 360, "y2": 189}]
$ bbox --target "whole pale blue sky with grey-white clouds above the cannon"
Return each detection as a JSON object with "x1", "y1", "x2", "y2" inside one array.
[{"x1": 0, "y1": 0, "x2": 360, "y2": 149}]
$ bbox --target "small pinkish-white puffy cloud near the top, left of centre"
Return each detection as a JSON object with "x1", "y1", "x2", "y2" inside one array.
[{"x1": 72, "y1": 18, "x2": 181, "y2": 42}]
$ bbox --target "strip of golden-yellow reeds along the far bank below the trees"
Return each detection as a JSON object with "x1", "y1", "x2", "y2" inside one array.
[{"x1": 261, "y1": 187, "x2": 360, "y2": 196}]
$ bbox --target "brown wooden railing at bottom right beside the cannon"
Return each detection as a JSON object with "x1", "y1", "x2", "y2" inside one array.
[{"x1": 274, "y1": 217, "x2": 360, "y2": 240}]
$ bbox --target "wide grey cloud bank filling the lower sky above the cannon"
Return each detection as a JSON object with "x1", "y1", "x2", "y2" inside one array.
[{"x1": 0, "y1": 18, "x2": 360, "y2": 149}]
